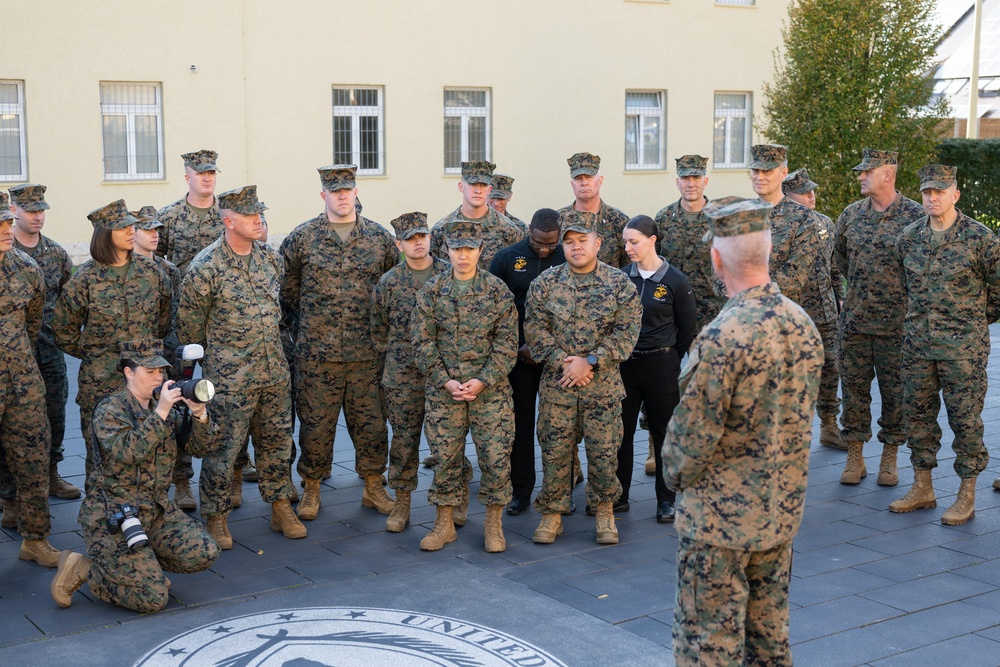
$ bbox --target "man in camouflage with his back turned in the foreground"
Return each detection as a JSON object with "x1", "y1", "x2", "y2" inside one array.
[{"x1": 663, "y1": 200, "x2": 823, "y2": 667}]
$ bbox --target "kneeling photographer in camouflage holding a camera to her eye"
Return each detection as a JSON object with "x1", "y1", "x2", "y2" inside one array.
[{"x1": 51, "y1": 340, "x2": 220, "y2": 613}]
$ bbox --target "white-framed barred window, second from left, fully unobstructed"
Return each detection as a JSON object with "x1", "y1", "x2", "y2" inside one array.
[{"x1": 101, "y1": 83, "x2": 163, "y2": 181}]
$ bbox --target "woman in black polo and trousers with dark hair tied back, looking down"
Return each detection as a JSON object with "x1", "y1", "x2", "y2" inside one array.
[{"x1": 615, "y1": 215, "x2": 696, "y2": 523}]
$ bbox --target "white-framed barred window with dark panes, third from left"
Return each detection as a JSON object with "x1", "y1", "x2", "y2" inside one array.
[{"x1": 333, "y1": 86, "x2": 385, "y2": 176}]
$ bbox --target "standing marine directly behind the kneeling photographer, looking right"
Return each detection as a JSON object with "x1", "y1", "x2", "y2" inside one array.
[{"x1": 178, "y1": 185, "x2": 306, "y2": 549}]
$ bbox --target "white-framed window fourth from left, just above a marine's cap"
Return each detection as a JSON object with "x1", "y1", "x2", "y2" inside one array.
[{"x1": 444, "y1": 88, "x2": 493, "y2": 174}]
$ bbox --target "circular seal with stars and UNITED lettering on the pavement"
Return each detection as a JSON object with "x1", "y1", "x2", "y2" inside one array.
[{"x1": 136, "y1": 607, "x2": 565, "y2": 667}]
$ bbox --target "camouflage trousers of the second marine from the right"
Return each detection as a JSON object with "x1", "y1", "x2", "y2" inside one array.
[{"x1": 840, "y1": 333, "x2": 906, "y2": 447}]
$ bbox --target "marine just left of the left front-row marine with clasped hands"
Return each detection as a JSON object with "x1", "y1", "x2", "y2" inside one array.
[{"x1": 371, "y1": 212, "x2": 451, "y2": 533}]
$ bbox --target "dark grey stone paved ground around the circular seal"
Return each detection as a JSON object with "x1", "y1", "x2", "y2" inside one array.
[{"x1": 0, "y1": 327, "x2": 1000, "y2": 667}]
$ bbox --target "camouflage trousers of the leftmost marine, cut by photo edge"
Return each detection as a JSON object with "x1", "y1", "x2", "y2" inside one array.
[{"x1": 0, "y1": 369, "x2": 52, "y2": 540}]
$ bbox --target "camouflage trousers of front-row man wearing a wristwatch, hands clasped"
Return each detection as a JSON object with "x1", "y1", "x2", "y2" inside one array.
[{"x1": 535, "y1": 399, "x2": 624, "y2": 514}]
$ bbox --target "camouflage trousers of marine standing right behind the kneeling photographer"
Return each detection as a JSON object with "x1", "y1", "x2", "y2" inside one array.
[{"x1": 198, "y1": 382, "x2": 292, "y2": 516}]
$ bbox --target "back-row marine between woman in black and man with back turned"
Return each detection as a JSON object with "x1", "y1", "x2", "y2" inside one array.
[{"x1": 654, "y1": 155, "x2": 726, "y2": 335}]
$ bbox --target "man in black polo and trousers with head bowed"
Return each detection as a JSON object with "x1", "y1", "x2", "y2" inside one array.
[{"x1": 490, "y1": 208, "x2": 566, "y2": 515}]
